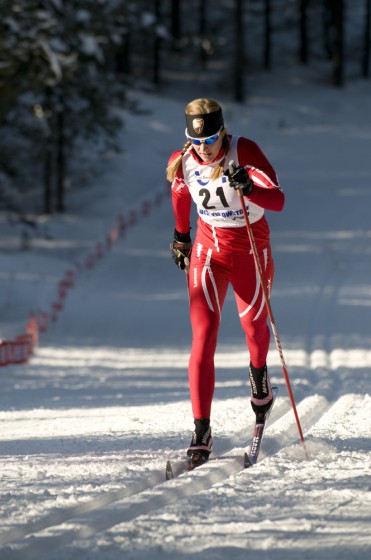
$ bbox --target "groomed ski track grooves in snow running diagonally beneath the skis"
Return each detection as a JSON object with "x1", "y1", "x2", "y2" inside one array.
[{"x1": 0, "y1": 395, "x2": 334, "y2": 560}]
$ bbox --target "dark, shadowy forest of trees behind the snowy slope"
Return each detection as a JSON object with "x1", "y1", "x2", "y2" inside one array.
[{"x1": 0, "y1": 0, "x2": 371, "y2": 225}]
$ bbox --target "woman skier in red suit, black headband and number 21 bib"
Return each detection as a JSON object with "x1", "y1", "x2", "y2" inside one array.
[{"x1": 167, "y1": 98, "x2": 285, "y2": 463}]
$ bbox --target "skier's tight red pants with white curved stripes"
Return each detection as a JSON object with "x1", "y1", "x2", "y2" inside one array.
[{"x1": 188, "y1": 238, "x2": 274, "y2": 418}]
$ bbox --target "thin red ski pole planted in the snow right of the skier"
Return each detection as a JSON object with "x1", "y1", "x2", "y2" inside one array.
[{"x1": 229, "y1": 161, "x2": 308, "y2": 459}]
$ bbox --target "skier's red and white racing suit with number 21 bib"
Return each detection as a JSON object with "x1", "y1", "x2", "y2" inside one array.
[{"x1": 169, "y1": 136, "x2": 284, "y2": 418}]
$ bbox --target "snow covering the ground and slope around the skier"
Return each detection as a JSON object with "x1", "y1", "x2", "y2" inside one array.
[{"x1": 0, "y1": 70, "x2": 371, "y2": 560}]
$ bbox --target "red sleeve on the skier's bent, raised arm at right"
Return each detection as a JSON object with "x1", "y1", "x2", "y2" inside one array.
[{"x1": 237, "y1": 138, "x2": 285, "y2": 212}]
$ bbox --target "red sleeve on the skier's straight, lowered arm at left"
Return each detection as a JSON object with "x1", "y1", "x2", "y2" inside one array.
[{"x1": 169, "y1": 150, "x2": 192, "y2": 233}]
